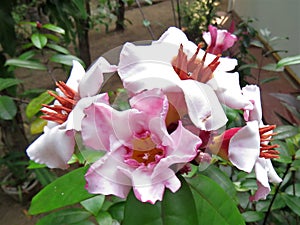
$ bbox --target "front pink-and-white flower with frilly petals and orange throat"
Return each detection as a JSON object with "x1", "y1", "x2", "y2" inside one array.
[{"x1": 82, "y1": 89, "x2": 201, "y2": 204}]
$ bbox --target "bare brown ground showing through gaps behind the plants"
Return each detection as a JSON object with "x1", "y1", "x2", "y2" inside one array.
[{"x1": 0, "y1": 0, "x2": 297, "y2": 225}]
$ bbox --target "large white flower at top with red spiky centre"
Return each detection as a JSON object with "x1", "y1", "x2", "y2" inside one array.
[{"x1": 118, "y1": 27, "x2": 252, "y2": 130}]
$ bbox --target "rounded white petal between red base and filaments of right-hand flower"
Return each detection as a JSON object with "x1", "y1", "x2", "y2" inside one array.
[{"x1": 228, "y1": 121, "x2": 260, "y2": 173}]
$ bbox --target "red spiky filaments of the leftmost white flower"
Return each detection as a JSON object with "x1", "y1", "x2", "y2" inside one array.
[{"x1": 41, "y1": 81, "x2": 78, "y2": 124}]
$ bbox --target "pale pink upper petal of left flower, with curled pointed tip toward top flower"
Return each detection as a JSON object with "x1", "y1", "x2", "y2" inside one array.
[{"x1": 79, "y1": 57, "x2": 117, "y2": 98}]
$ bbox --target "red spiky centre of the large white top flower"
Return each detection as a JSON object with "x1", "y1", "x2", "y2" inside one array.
[{"x1": 172, "y1": 43, "x2": 220, "y2": 83}]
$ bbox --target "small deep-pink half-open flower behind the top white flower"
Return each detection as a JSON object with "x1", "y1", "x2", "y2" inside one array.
[{"x1": 202, "y1": 25, "x2": 237, "y2": 55}]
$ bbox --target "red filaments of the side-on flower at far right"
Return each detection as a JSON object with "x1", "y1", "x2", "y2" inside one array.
[{"x1": 259, "y1": 125, "x2": 279, "y2": 159}]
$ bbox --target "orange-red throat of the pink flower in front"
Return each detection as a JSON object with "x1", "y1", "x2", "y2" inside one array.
[{"x1": 129, "y1": 135, "x2": 165, "y2": 166}]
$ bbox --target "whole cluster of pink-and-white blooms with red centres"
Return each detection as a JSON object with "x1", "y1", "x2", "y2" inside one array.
[{"x1": 27, "y1": 26, "x2": 281, "y2": 204}]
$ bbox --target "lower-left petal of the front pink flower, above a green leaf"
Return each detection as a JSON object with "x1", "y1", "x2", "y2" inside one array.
[{"x1": 85, "y1": 149, "x2": 132, "y2": 198}]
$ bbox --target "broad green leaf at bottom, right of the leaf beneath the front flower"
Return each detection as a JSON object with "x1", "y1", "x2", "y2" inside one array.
[{"x1": 188, "y1": 175, "x2": 245, "y2": 225}]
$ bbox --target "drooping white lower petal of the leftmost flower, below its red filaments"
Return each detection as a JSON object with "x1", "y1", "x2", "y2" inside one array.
[{"x1": 26, "y1": 124, "x2": 75, "y2": 169}]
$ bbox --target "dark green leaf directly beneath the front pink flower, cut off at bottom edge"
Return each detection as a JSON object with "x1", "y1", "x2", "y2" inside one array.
[{"x1": 122, "y1": 177, "x2": 198, "y2": 225}]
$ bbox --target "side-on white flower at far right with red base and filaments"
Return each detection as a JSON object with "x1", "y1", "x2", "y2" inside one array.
[{"x1": 213, "y1": 85, "x2": 282, "y2": 201}]
